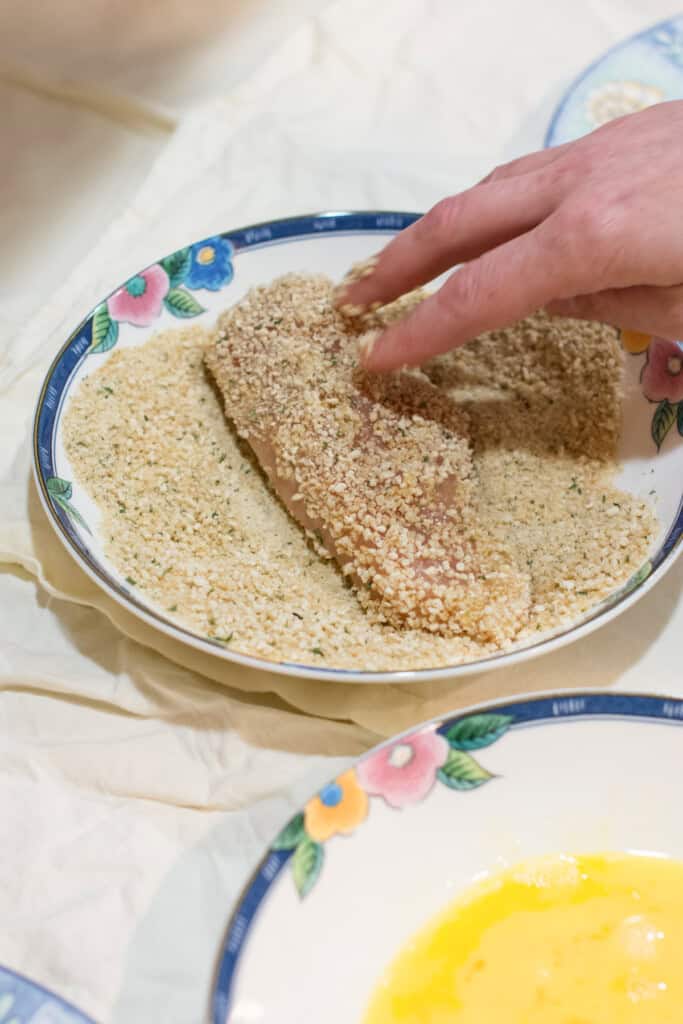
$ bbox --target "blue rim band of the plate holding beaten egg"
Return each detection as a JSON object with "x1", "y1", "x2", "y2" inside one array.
[{"x1": 210, "y1": 689, "x2": 683, "y2": 1024}]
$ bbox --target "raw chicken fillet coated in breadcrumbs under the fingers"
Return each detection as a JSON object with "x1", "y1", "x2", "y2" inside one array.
[{"x1": 206, "y1": 274, "x2": 529, "y2": 643}]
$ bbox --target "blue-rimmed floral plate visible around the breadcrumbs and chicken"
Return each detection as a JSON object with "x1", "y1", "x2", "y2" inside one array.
[{"x1": 34, "y1": 212, "x2": 683, "y2": 682}]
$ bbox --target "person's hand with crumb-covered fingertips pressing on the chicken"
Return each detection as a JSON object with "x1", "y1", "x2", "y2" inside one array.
[{"x1": 339, "y1": 101, "x2": 683, "y2": 372}]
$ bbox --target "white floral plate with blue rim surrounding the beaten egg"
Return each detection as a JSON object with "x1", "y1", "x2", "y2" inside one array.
[{"x1": 211, "y1": 691, "x2": 683, "y2": 1024}]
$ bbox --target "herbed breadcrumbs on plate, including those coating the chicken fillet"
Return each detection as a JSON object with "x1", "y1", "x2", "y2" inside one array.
[{"x1": 63, "y1": 276, "x2": 656, "y2": 671}]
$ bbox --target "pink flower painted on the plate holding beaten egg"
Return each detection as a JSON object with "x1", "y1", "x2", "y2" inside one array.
[{"x1": 355, "y1": 729, "x2": 449, "y2": 808}]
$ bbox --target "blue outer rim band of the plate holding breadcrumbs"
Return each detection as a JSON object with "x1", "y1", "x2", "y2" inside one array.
[{"x1": 33, "y1": 210, "x2": 683, "y2": 684}]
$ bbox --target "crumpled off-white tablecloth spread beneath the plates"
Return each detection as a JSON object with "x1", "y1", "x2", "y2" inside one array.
[{"x1": 0, "y1": 0, "x2": 683, "y2": 1024}]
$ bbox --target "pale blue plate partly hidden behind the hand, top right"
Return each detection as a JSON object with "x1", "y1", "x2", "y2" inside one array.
[{"x1": 546, "y1": 14, "x2": 683, "y2": 145}]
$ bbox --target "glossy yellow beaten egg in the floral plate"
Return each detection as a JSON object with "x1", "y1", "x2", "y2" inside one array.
[{"x1": 365, "y1": 854, "x2": 683, "y2": 1024}]
